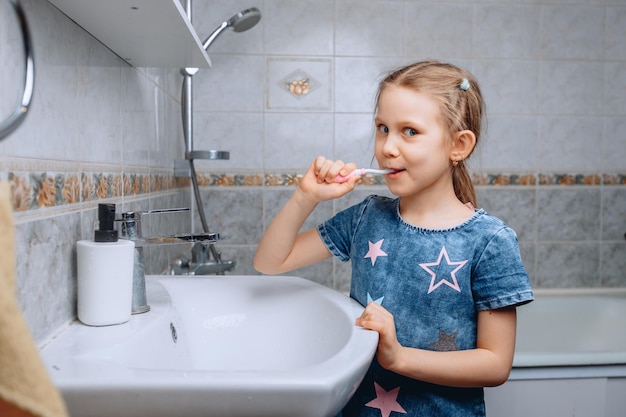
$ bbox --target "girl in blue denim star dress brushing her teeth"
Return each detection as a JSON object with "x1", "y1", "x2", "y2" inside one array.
[{"x1": 254, "y1": 62, "x2": 533, "y2": 417}]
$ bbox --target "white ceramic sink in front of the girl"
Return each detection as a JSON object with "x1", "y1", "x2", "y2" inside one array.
[{"x1": 41, "y1": 276, "x2": 378, "y2": 417}]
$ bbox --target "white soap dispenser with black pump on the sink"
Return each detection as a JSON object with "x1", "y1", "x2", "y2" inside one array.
[{"x1": 76, "y1": 204, "x2": 135, "y2": 326}]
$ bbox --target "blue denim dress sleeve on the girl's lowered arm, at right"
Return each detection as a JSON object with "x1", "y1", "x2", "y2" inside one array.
[{"x1": 472, "y1": 226, "x2": 533, "y2": 311}]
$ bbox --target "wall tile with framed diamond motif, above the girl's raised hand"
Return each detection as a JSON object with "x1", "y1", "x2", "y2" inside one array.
[{"x1": 267, "y1": 58, "x2": 333, "y2": 111}]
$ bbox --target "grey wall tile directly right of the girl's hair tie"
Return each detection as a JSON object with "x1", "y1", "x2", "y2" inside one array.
[{"x1": 473, "y1": 59, "x2": 539, "y2": 118}]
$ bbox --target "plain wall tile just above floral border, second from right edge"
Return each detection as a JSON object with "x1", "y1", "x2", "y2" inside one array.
[{"x1": 535, "y1": 115, "x2": 604, "y2": 172}]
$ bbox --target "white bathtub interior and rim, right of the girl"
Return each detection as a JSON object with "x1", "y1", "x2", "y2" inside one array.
[{"x1": 513, "y1": 289, "x2": 626, "y2": 371}]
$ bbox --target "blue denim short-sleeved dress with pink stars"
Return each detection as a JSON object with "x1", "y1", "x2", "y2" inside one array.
[{"x1": 318, "y1": 196, "x2": 533, "y2": 417}]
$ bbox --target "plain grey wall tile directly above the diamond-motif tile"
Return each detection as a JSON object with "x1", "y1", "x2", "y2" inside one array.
[{"x1": 263, "y1": 0, "x2": 335, "y2": 56}]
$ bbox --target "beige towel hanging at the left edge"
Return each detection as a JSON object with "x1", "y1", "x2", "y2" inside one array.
[{"x1": 0, "y1": 182, "x2": 67, "y2": 417}]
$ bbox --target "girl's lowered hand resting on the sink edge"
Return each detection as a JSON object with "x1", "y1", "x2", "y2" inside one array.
[{"x1": 356, "y1": 301, "x2": 404, "y2": 370}]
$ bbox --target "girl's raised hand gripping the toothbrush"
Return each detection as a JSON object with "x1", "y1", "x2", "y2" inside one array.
[{"x1": 299, "y1": 156, "x2": 361, "y2": 202}]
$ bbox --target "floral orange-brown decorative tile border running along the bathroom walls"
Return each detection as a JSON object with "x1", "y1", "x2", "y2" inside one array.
[{"x1": 3, "y1": 165, "x2": 626, "y2": 212}]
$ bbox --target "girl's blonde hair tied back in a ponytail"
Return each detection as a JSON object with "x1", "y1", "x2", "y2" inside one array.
[{"x1": 376, "y1": 61, "x2": 485, "y2": 207}]
